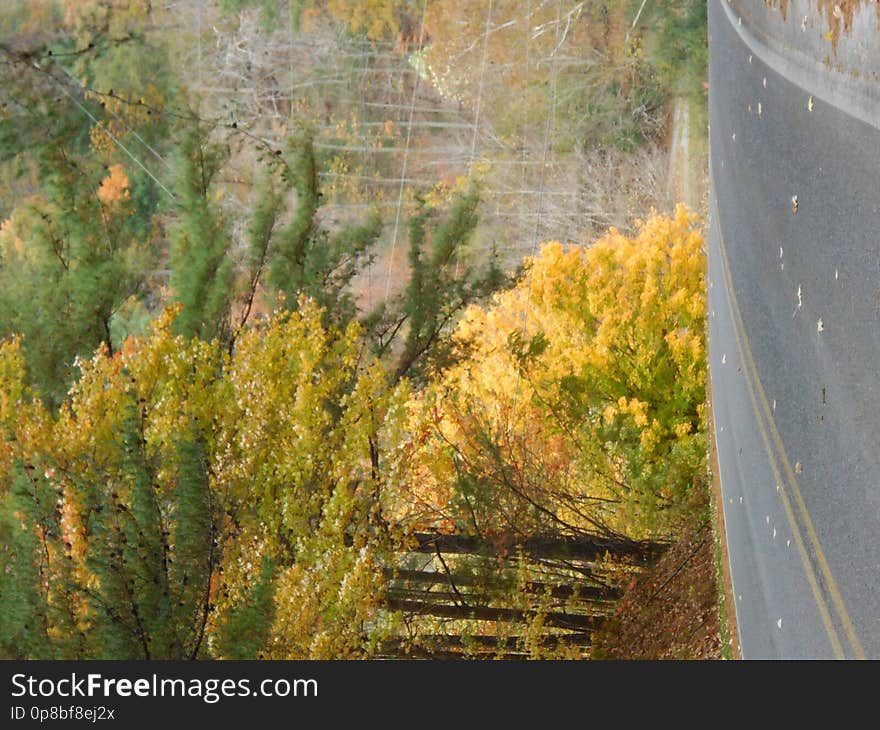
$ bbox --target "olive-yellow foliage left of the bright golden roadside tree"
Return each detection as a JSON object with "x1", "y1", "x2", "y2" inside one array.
[{"x1": 0, "y1": 299, "x2": 409, "y2": 658}]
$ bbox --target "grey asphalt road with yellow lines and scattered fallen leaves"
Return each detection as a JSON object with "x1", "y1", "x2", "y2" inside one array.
[{"x1": 709, "y1": 0, "x2": 880, "y2": 659}]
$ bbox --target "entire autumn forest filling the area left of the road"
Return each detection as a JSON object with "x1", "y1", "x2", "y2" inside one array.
[{"x1": 0, "y1": 0, "x2": 725, "y2": 658}]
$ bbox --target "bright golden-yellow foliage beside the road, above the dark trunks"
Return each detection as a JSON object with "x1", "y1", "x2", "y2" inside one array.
[{"x1": 410, "y1": 206, "x2": 706, "y2": 534}]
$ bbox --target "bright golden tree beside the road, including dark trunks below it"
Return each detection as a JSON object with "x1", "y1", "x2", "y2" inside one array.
[{"x1": 362, "y1": 208, "x2": 706, "y2": 657}]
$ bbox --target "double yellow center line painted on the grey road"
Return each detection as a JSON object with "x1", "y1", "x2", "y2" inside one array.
[{"x1": 711, "y1": 185, "x2": 865, "y2": 659}]
